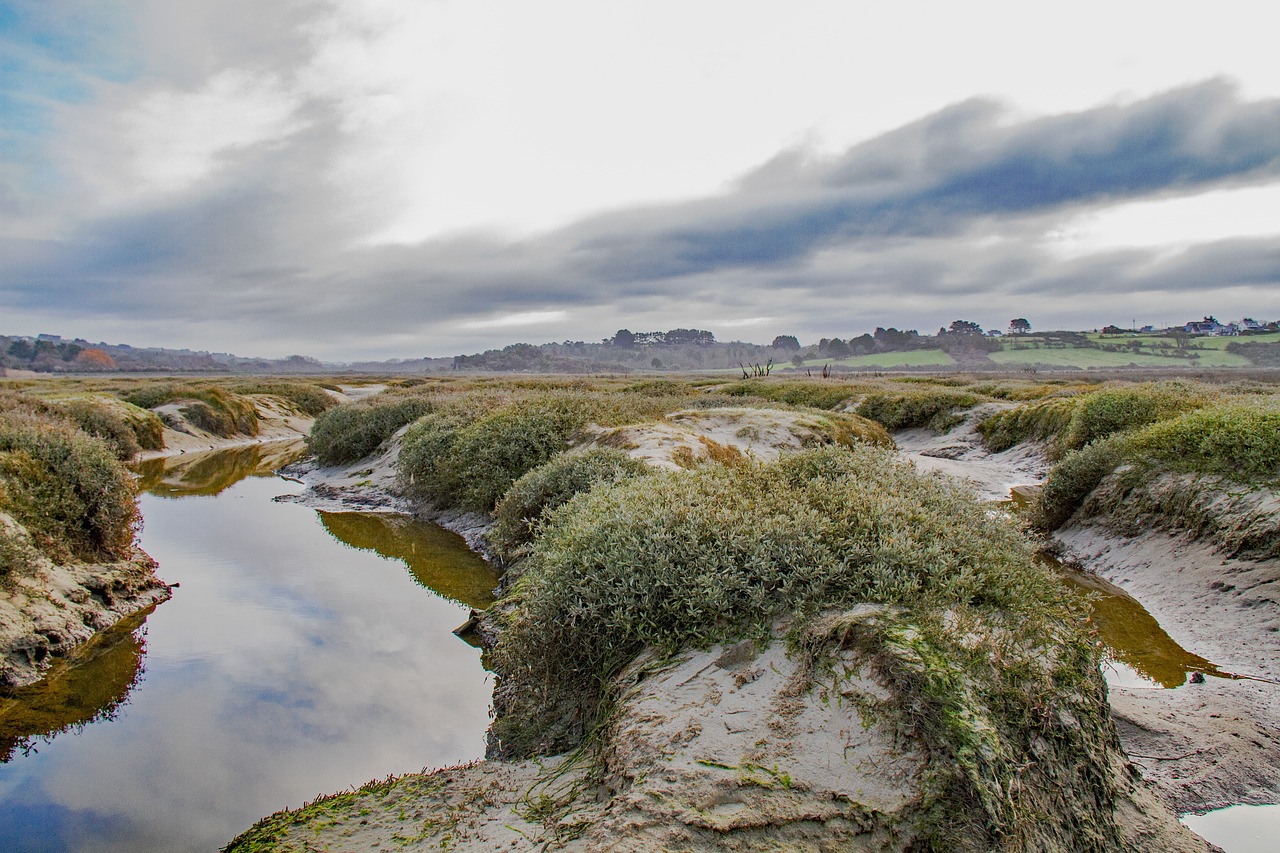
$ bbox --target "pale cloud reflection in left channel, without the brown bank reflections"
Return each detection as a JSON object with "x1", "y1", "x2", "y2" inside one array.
[{"x1": 10, "y1": 480, "x2": 492, "y2": 850}]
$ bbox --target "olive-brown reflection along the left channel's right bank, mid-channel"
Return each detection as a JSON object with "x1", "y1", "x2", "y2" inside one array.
[{"x1": 320, "y1": 512, "x2": 498, "y2": 610}]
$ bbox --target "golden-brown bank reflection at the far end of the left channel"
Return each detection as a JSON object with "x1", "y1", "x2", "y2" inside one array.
[{"x1": 133, "y1": 438, "x2": 307, "y2": 497}]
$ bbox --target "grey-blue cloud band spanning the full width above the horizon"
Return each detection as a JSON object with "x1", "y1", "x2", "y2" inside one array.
[{"x1": 0, "y1": 82, "x2": 1280, "y2": 355}]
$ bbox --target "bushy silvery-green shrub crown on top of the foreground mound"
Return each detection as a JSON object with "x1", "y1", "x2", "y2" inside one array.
[{"x1": 486, "y1": 446, "x2": 1066, "y2": 754}]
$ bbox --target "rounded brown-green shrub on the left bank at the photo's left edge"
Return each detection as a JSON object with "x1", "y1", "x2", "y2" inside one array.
[{"x1": 0, "y1": 412, "x2": 138, "y2": 561}]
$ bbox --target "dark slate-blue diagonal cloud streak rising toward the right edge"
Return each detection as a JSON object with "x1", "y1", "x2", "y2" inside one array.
[{"x1": 565, "y1": 83, "x2": 1280, "y2": 280}]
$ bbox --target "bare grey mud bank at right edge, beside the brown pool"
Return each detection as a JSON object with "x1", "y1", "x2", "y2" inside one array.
[{"x1": 1055, "y1": 525, "x2": 1280, "y2": 812}]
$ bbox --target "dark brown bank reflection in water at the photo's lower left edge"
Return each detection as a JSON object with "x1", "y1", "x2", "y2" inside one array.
[{"x1": 0, "y1": 607, "x2": 155, "y2": 763}]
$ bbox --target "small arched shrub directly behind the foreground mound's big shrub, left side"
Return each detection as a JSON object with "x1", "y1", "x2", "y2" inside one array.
[{"x1": 489, "y1": 447, "x2": 652, "y2": 560}]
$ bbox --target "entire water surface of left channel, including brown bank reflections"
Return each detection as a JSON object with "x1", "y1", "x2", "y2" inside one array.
[{"x1": 0, "y1": 446, "x2": 495, "y2": 853}]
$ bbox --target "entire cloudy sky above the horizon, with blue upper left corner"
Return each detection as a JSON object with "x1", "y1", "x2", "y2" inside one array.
[{"x1": 0, "y1": 0, "x2": 1280, "y2": 360}]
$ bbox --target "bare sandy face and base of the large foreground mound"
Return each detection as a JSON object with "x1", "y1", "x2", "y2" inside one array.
[{"x1": 230, "y1": 625, "x2": 1208, "y2": 853}]
